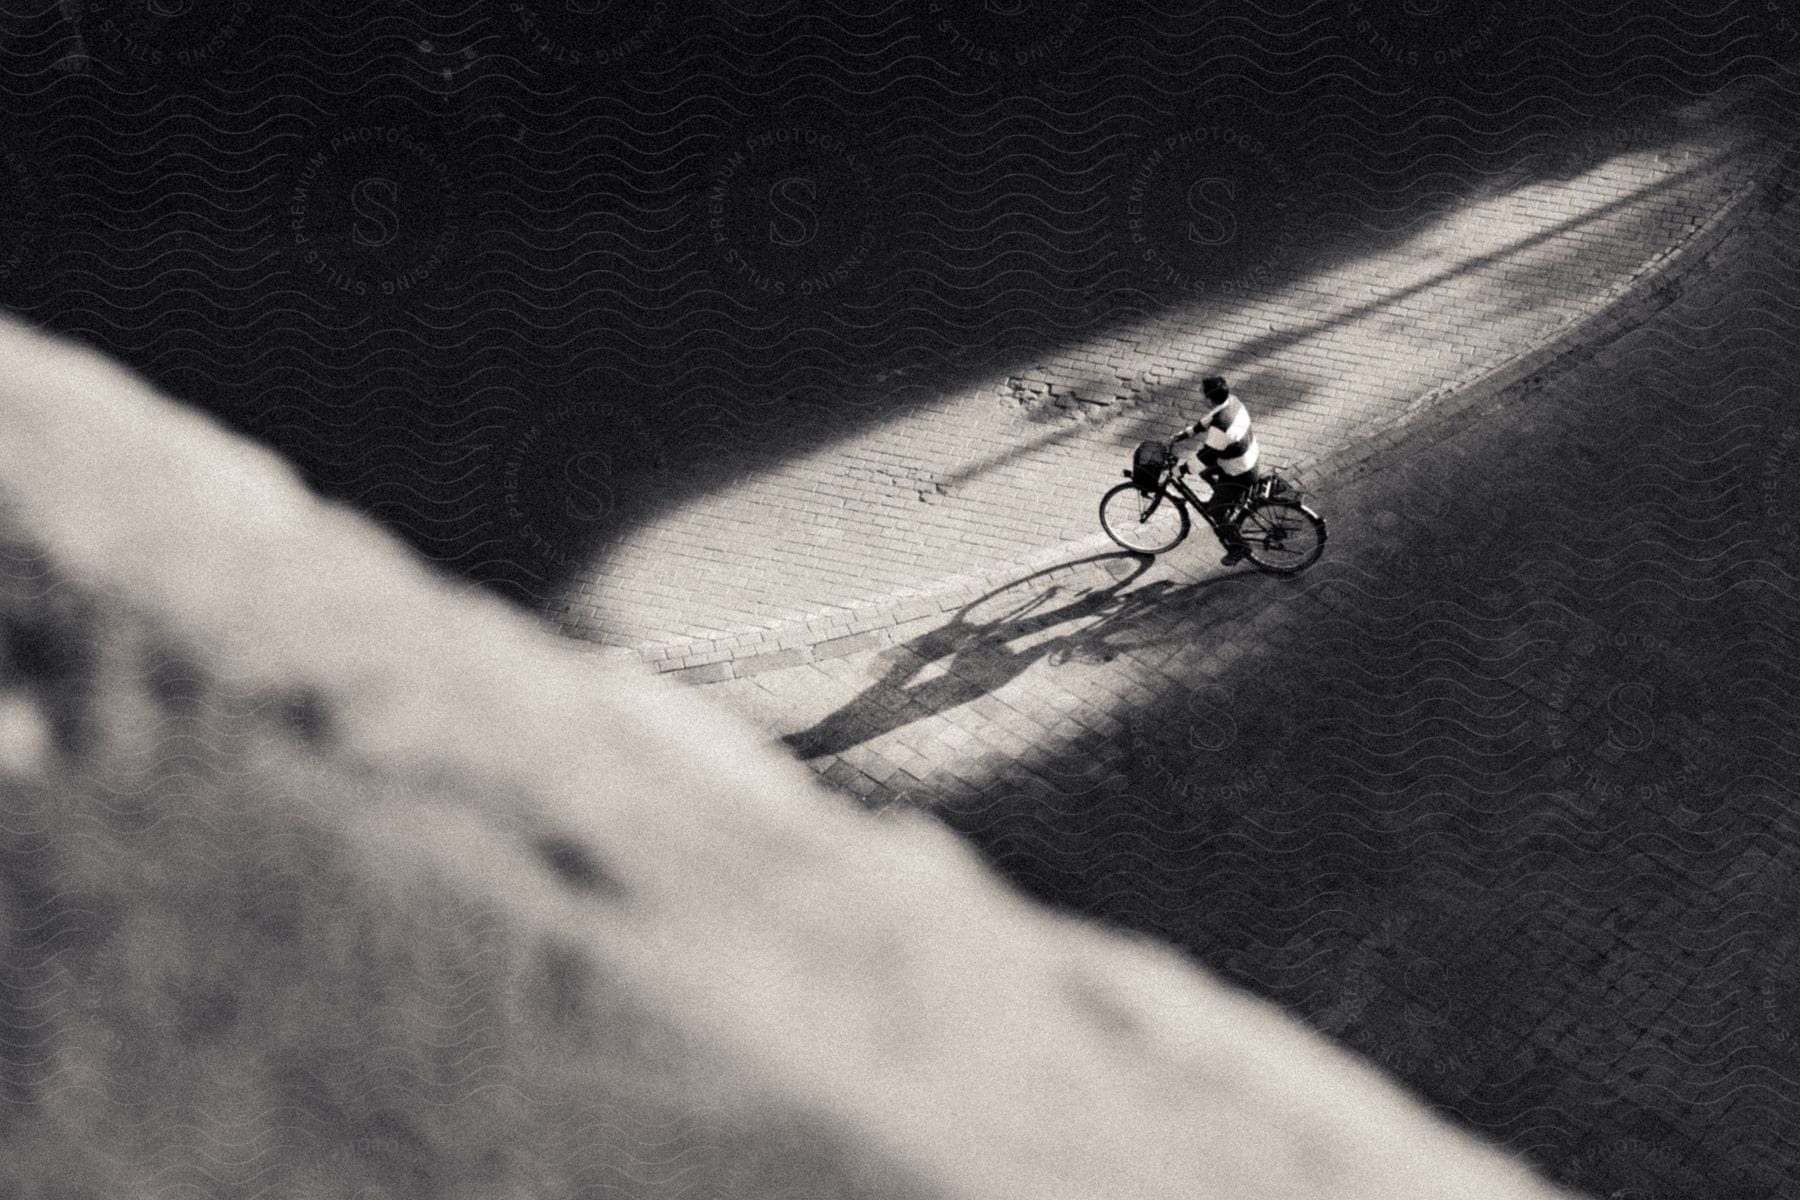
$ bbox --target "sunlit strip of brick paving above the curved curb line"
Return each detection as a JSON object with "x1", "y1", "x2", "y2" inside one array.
[{"x1": 565, "y1": 91, "x2": 1766, "y2": 669}]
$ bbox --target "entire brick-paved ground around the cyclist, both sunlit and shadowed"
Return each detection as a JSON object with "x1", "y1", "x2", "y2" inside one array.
[{"x1": 10, "y1": 0, "x2": 1800, "y2": 1200}]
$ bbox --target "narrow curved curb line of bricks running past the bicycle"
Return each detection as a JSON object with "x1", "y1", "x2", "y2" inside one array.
[{"x1": 615, "y1": 109, "x2": 1800, "y2": 684}]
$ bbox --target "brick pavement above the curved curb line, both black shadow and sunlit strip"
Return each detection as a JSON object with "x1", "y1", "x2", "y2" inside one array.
[{"x1": 0, "y1": 0, "x2": 1800, "y2": 647}]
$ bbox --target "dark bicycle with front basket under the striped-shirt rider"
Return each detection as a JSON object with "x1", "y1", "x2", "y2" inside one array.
[{"x1": 1100, "y1": 441, "x2": 1327, "y2": 576}]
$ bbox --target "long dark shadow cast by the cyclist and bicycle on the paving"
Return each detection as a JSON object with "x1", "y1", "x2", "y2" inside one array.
[{"x1": 781, "y1": 552, "x2": 1255, "y2": 759}]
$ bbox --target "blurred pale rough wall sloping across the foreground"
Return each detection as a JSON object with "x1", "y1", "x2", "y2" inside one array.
[{"x1": 0, "y1": 314, "x2": 1576, "y2": 1200}]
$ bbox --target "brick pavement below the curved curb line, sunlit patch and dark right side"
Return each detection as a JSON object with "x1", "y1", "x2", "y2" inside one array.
[{"x1": 707, "y1": 124, "x2": 1800, "y2": 1200}]
